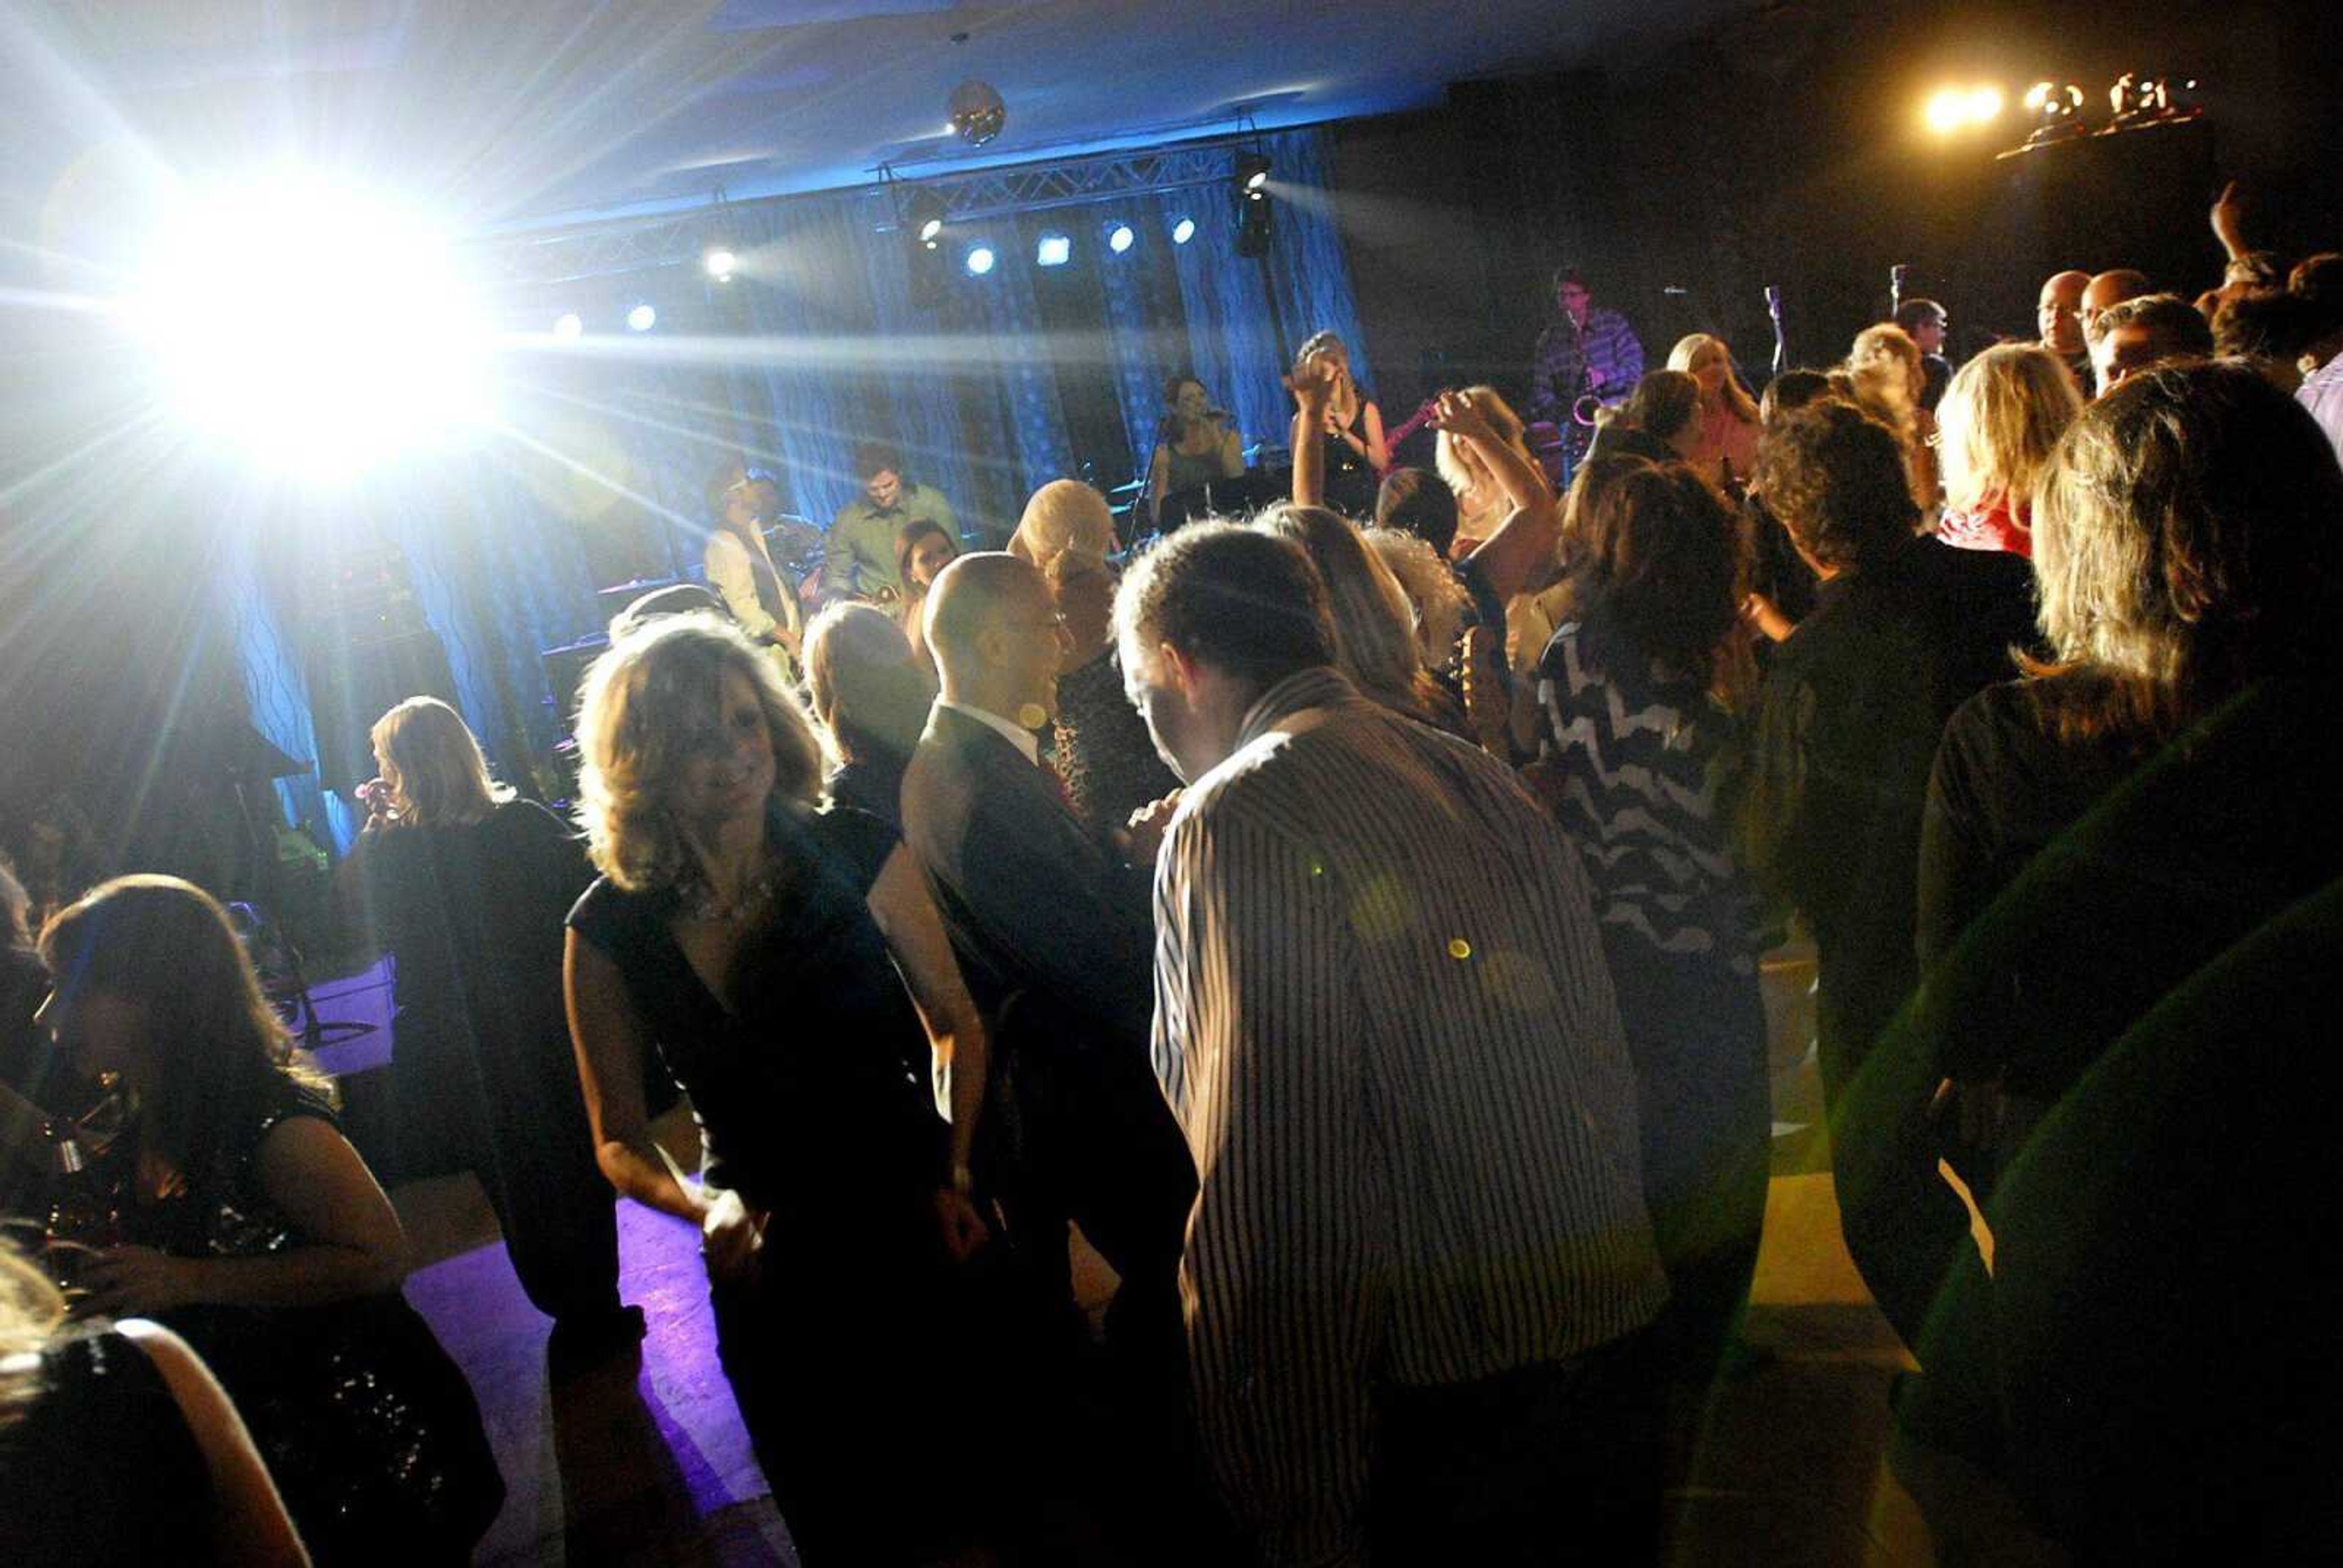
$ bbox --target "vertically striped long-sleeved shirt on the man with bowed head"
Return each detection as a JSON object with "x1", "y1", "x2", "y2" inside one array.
[{"x1": 1155, "y1": 671, "x2": 1666, "y2": 1563}]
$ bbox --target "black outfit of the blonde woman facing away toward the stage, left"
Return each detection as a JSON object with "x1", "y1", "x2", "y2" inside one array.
[{"x1": 359, "y1": 802, "x2": 619, "y2": 1334}]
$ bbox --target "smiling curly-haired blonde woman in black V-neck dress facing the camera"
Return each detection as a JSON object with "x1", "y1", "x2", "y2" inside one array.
[{"x1": 569, "y1": 616, "x2": 987, "y2": 1566}]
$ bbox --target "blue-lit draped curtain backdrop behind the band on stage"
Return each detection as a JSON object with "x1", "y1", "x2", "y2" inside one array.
[{"x1": 225, "y1": 131, "x2": 1373, "y2": 846}]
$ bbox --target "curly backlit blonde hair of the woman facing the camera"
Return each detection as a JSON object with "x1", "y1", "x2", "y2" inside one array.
[{"x1": 578, "y1": 614, "x2": 822, "y2": 893}]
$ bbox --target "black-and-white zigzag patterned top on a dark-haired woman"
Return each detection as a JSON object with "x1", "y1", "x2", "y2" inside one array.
[{"x1": 1525, "y1": 610, "x2": 1757, "y2": 975}]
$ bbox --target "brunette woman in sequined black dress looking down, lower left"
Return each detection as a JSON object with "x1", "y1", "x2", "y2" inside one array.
[{"x1": 40, "y1": 877, "x2": 504, "y2": 1563}]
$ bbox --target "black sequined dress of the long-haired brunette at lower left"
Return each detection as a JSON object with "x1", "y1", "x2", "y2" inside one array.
[{"x1": 115, "y1": 1078, "x2": 504, "y2": 1563}]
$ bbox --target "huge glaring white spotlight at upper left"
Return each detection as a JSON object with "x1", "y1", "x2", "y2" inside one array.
[{"x1": 126, "y1": 173, "x2": 492, "y2": 476}]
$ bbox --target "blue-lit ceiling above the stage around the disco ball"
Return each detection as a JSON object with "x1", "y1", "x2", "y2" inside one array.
[{"x1": 0, "y1": 0, "x2": 1746, "y2": 242}]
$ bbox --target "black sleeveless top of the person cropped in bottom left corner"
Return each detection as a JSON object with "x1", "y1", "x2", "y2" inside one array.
[{"x1": 0, "y1": 1324, "x2": 213, "y2": 1568}]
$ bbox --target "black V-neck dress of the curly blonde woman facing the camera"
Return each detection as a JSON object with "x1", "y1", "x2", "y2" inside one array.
[{"x1": 569, "y1": 806, "x2": 974, "y2": 1563}]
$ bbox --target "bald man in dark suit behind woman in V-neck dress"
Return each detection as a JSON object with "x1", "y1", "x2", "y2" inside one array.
[{"x1": 902, "y1": 553, "x2": 1195, "y2": 1364}]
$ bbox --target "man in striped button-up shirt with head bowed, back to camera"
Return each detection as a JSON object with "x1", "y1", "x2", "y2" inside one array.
[{"x1": 1115, "y1": 523, "x2": 1666, "y2": 1563}]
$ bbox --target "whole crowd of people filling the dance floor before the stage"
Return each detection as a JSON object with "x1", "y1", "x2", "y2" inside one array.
[{"x1": 0, "y1": 171, "x2": 2343, "y2": 1566}]
